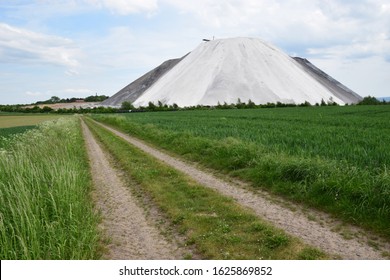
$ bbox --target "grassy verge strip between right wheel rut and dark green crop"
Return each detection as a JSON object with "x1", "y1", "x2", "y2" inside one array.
[{"x1": 90, "y1": 112, "x2": 390, "y2": 239}]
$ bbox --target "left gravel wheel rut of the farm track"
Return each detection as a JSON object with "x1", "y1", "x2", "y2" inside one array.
[{"x1": 82, "y1": 119, "x2": 182, "y2": 260}]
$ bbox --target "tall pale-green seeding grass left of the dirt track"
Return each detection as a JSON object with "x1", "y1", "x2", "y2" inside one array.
[{"x1": 0, "y1": 118, "x2": 99, "y2": 259}]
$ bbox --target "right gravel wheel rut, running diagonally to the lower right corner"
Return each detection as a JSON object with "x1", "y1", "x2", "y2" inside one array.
[{"x1": 98, "y1": 119, "x2": 390, "y2": 259}]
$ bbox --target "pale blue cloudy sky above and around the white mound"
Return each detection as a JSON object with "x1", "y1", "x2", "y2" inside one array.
[{"x1": 0, "y1": 0, "x2": 390, "y2": 104}]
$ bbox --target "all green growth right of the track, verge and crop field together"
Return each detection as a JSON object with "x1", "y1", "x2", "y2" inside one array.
[{"x1": 90, "y1": 106, "x2": 390, "y2": 239}]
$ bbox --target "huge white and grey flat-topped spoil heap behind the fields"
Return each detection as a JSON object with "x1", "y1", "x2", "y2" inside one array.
[{"x1": 102, "y1": 38, "x2": 362, "y2": 107}]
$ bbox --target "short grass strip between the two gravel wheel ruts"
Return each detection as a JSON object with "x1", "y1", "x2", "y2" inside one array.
[{"x1": 87, "y1": 117, "x2": 325, "y2": 259}]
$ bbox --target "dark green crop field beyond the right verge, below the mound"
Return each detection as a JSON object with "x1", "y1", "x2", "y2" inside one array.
[{"x1": 94, "y1": 106, "x2": 390, "y2": 168}]
